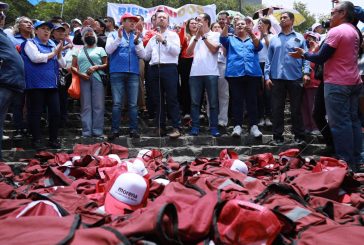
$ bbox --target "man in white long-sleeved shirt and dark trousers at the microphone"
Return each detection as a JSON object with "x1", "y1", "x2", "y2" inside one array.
[{"x1": 144, "y1": 12, "x2": 181, "y2": 138}]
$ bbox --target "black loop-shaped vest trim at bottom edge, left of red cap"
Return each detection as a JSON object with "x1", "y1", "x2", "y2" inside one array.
[{"x1": 156, "y1": 203, "x2": 182, "y2": 245}]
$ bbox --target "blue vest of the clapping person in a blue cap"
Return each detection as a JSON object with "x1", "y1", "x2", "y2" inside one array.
[{"x1": 21, "y1": 37, "x2": 59, "y2": 89}]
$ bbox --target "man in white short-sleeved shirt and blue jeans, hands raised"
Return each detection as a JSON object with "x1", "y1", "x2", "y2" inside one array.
[{"x1": 187, "y1": 13, "x2": 220, "y2": 137}]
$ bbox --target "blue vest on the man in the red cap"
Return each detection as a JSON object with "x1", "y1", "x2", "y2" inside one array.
[{"x1": 109, "y1": 30, "x2": 139, "y2": 75}]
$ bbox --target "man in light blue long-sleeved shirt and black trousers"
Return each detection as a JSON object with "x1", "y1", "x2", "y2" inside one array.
[{"x1": 264, "y1": 12, "x2": 310, "y2": 145}]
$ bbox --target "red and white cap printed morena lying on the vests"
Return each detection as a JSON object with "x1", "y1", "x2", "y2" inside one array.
[{"x1": 105, "y1": 172, "x2": 149, "y2": 215}]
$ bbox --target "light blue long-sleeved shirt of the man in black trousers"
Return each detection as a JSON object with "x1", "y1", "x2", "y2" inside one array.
[{"x1": 264, "y1": 31, "x2": 310, "y2": 81}]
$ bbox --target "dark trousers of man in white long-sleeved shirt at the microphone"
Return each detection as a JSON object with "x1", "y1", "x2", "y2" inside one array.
[{"x1": 150, "y1": 64, "x2": 181, "y2": 128}]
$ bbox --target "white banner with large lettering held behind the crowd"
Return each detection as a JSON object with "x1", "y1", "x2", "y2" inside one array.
[{"x1": 107, "y1": 3, "x2": 216, "y2": 29}]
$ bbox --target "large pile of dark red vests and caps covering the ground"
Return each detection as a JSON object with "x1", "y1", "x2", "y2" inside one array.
[{"x1": 0, "y1": 143, "x2": 364, "y2": 244}]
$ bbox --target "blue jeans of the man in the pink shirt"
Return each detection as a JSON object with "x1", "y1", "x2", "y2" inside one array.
[{"x1": 324, "y1": 83, "x2": 362, "y2": 170}]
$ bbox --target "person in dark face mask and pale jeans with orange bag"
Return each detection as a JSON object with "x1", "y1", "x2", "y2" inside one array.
[{"x1": 71, "y1": 27, "x2": 107, "y2": 138}]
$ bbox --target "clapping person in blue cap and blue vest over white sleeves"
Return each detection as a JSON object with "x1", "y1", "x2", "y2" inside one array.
[{"x1": 21, "y1": 21, "x2": 66, "y2": 150}]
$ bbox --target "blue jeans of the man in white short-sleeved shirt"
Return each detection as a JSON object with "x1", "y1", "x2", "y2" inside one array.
[{"x1": 190, "y1": 75, "x2": 219, "y2": 128}]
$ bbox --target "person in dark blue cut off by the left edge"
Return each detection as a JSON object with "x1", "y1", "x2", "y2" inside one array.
[{"x1": 0, "y1": 2, "x2": 25, "y2": 160}]
